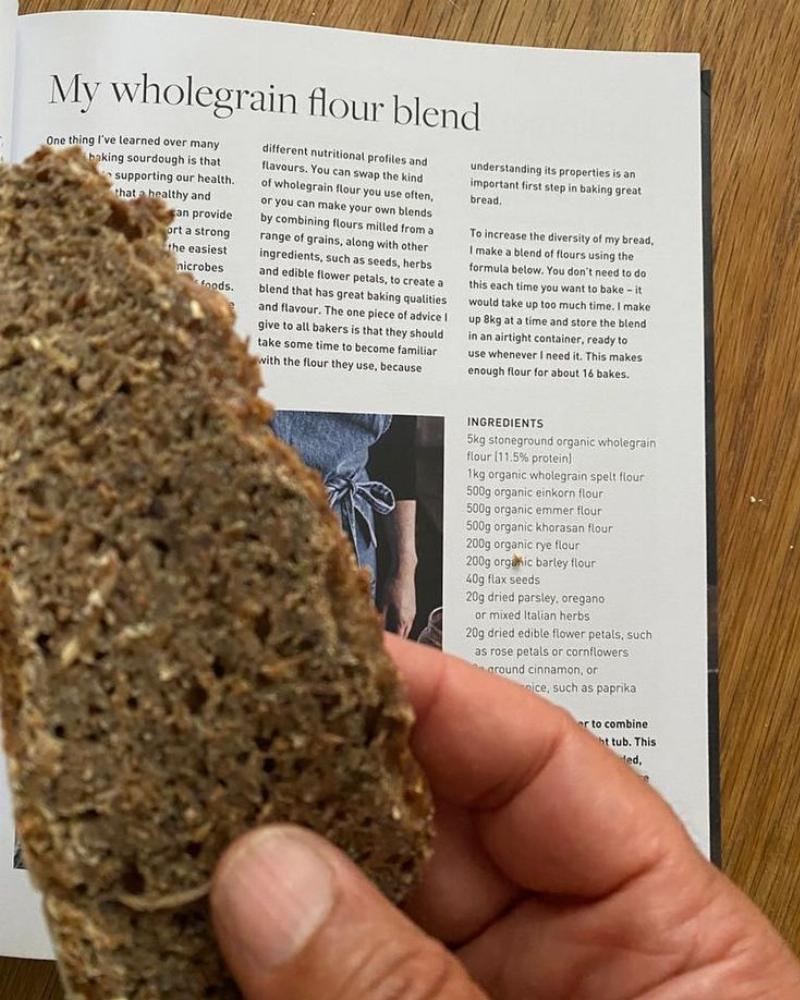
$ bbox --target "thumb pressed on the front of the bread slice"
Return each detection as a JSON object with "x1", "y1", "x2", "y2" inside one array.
[{"x1": 211, "y1": 826, "x2": 486, "y2": 1000}]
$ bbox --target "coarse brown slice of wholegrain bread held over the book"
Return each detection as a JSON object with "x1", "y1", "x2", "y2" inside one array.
[{"x1": 0, "y1": 150, "x2": 430, "y2": 1000}]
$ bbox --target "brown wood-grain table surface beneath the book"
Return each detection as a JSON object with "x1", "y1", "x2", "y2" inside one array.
[{"x1": 6, "y1": 0, "x2": 800, "y2": 1000}]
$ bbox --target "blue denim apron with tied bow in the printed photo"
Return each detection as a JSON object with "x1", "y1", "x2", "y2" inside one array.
[{"x1": 272, "y1": 410, "x2": 395, "y2": 592}]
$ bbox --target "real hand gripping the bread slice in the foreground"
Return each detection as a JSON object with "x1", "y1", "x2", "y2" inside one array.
[{"x1": 211, "y1": 637, "x2": 800, "y2": 1000}]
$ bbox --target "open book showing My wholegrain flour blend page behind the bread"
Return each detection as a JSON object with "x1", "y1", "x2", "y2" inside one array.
[{"x1": 0, "y1": 0, "x2": 718, "y2": 956}]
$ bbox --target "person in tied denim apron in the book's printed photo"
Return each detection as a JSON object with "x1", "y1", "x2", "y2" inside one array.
[{"x1": 272, "y1": 410, "x2": 417, "y2": 638}]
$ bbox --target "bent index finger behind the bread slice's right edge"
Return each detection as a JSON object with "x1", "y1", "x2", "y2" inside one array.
[{"x1": 386, "y1": 636, "x2": 694, "y2": 897}]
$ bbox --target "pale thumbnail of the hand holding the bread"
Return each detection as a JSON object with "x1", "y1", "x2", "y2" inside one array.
[{"x1": 213, "y1": 829, "x2": 334, "y2": 970}]
